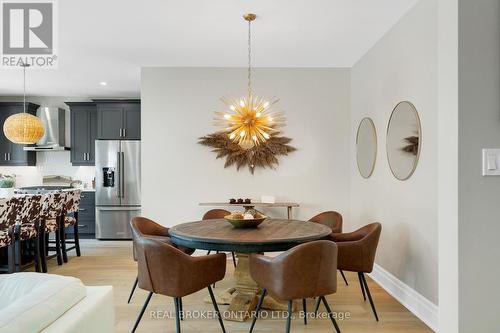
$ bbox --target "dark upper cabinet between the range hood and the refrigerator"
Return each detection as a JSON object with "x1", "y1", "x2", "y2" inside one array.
[{"x1": 66, "y1": 102, "x2": 97, "y2": 165}]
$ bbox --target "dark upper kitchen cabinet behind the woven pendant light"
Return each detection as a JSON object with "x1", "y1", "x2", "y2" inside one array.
[{"x1": 0, "y1": 102, "x2": 39, "y2": 166}]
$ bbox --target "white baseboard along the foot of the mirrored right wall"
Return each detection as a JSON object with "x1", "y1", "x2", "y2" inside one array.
[{"x1": 369, "y1": 264, "x2": 439, "y2": 332}]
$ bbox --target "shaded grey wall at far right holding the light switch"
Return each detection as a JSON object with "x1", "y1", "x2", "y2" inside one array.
[{"x1": 458, "y1": 0, "x2": 500, "y2": 333}]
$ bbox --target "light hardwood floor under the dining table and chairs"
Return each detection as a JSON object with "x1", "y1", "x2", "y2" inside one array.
[{"x1": 49, "y1": 240, "x2": 432, "y2": 333}]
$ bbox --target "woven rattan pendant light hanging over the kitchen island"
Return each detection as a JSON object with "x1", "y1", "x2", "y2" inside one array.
[{"x1": 3, "y1": 64, "x2": 45, "y2": 145}]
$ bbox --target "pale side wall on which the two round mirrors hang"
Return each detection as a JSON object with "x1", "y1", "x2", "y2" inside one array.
[{"x1": 347, "y1": 0, "x2": 438, "y2": 304}]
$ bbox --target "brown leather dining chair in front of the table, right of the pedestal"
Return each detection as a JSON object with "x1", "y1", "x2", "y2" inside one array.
[{"x1": 250, "y1": 240, "x2": 340, "y2": 333}]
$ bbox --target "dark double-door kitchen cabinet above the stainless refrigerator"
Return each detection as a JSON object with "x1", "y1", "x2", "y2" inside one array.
[{"x1": 94, "y1": 99, "x2": 141, "y2": 140}]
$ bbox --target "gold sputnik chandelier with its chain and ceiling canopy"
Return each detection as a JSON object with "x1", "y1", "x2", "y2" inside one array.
[{"x1": 216, "y1": 13, "x2": 285, "y2": 149}]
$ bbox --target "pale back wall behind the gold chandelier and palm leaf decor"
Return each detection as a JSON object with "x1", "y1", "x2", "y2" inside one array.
[{"x1": 141, "y1": 68, "x2": 350, "y2": 226}]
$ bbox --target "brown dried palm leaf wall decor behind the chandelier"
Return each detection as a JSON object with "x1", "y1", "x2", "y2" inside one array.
[{"x1": 198, "y1": 132, "x2": 296, "y2": 174}]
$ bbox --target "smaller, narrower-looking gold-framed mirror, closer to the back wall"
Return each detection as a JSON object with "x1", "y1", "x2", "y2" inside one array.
[{"x1": 356, "y1": 117, "x2": 377, "y2": 178}]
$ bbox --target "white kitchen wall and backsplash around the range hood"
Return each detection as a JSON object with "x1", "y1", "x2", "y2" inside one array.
[{"x1": 0, "y1": 96, "x2": 95, "y2": 187}]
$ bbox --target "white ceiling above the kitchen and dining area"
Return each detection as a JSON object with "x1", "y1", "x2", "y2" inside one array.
[{"x1": 0, "y1": 0, "x2": 417, "y2": 97}]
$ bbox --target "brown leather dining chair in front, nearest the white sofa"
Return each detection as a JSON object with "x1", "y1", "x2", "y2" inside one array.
[{"x1": 131, "y1": 220, "x2": 226, "y2": 333}]
